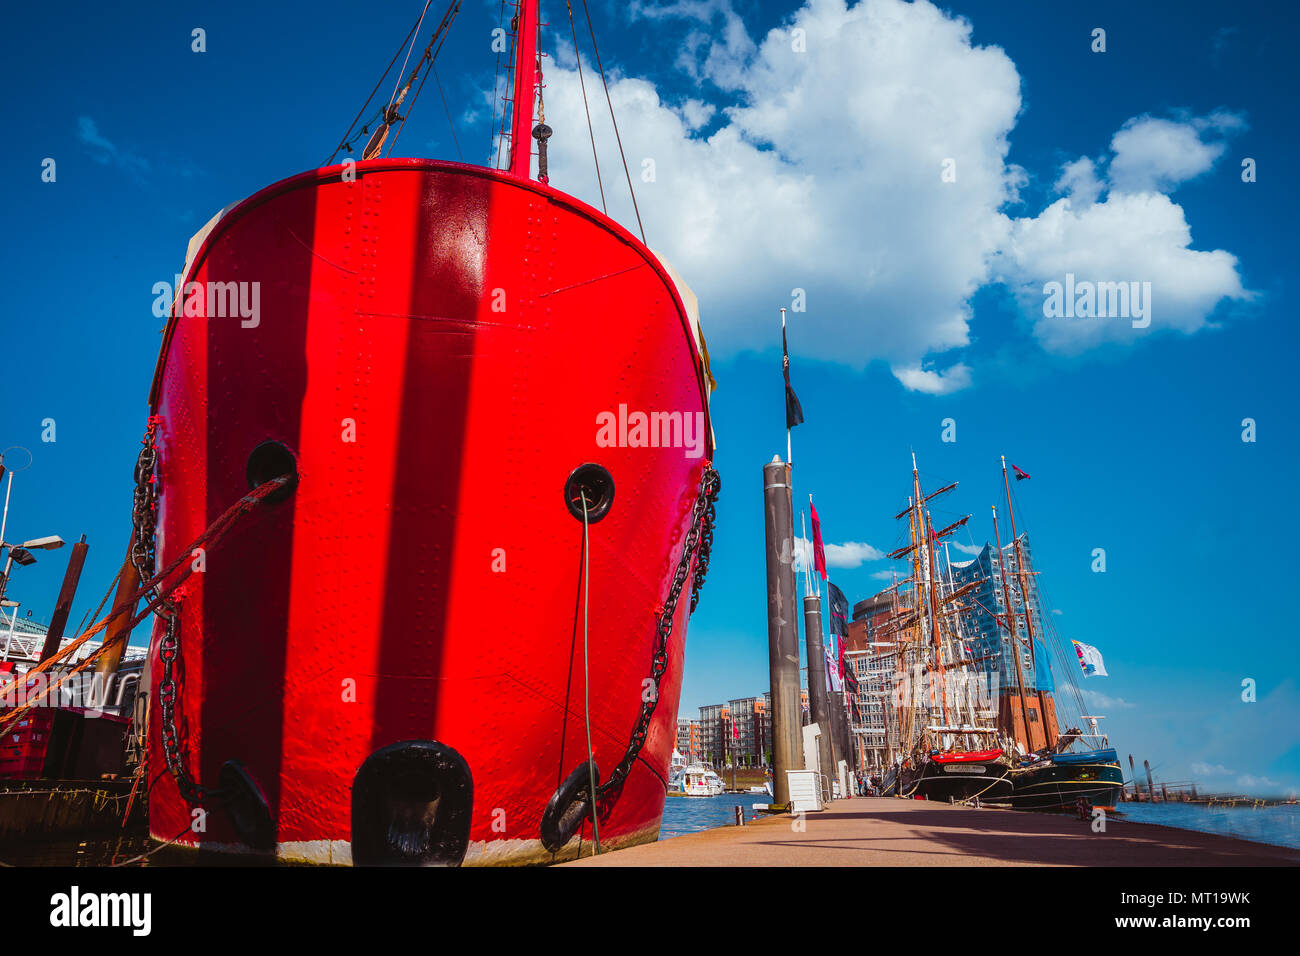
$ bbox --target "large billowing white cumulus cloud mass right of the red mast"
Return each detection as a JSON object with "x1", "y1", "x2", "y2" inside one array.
[{"x1": 533, "y1": 0, "x2": 1248, "y2": 395}]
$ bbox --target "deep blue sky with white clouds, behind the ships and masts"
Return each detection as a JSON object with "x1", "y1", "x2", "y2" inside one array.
[{"x1": 0, "y1": 0, "x2": 1300, "y2": 792}]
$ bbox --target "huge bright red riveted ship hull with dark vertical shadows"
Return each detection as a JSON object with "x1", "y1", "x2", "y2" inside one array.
[{"x1": 150, "y1": 160, "x2": 712, "y2": 865}]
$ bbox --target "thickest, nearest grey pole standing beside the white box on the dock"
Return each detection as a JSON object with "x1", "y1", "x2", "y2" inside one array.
[{"x1": 763, "y1": 458, "x2": 803, "y2": 806}]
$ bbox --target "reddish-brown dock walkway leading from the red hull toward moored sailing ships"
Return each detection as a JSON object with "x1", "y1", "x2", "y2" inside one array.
[{"x1": 564, "y1": 797, "x2": 1300, "y2": 866}]
